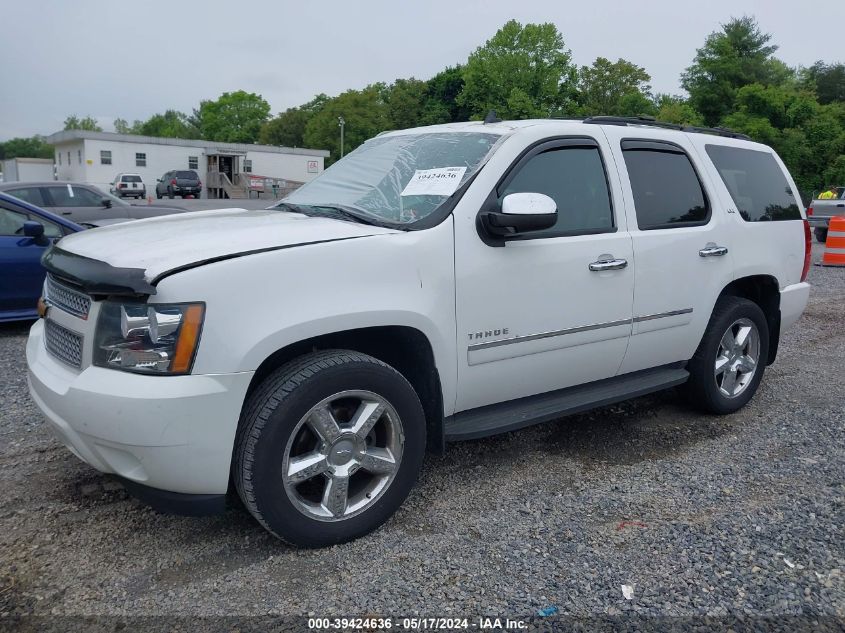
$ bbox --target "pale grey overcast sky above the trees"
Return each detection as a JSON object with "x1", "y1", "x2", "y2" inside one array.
[{"x1": 0, "y1": 0, "x2": 845, "y2": 140}]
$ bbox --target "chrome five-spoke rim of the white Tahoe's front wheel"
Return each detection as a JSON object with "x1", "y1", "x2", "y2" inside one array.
[{"x1": 282, "y1": 391, "x2": 405, "y2": 521}]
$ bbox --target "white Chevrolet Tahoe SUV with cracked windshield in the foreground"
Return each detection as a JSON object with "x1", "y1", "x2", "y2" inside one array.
[{"x1": 27, "y1": 117, "x2": 810, "y2": 546}]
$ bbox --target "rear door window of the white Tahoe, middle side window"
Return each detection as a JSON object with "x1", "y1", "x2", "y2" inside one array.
[{"x1": 622, "y1": 141, "x2": 710, "y2": 230}]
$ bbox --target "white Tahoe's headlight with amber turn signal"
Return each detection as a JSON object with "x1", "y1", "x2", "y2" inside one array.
[{"x1": 93, "y1": 301, "x2": 205, "y2": 374}]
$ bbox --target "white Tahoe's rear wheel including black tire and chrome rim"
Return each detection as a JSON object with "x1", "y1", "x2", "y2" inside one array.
[{"x1": 685, "y1": 297, "x2": 769, "y2": 415}]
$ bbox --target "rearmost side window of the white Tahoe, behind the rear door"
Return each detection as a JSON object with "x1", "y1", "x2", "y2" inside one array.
[{"x1": 705, "y1": 145, "x2": 801, "y2": 222}]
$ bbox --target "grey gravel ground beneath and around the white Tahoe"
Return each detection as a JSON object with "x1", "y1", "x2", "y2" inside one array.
[{"x1": 0, "y1": 245, "x2": 845, "y2": 628}]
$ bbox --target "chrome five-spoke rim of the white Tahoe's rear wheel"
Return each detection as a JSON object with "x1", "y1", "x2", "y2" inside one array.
[{"x1": 714, "y1": 318, "x2": 760, "y2": 398}]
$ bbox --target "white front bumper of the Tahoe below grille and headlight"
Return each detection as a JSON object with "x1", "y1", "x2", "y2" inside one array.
[{"x1": 26, "y1": 321, "x2": 252, "y2": 495}]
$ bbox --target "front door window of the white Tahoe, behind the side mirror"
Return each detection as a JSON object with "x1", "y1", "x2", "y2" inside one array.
[{"x1": 498, "y1": 146, "x2": 613, "y2": 239}]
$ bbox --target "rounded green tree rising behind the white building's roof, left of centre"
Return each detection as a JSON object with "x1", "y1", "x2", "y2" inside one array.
[{"x1": 199, "y1": 90, "x2": 270, "y2": 143}]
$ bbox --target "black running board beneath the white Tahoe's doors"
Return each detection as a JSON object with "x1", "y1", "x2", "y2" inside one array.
[{"x1": 444, "y1": 364, "x2": 689, "y2": 442}]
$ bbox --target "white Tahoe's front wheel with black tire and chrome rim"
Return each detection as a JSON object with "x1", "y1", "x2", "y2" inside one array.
[{"x1": 232, "y1": 350, "x2": 425, "y2": 547}]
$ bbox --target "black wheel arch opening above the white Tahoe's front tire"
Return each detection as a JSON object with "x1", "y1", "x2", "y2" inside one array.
[{"x1": 243, "y1": 325, "x2": 445, "y2": 453}]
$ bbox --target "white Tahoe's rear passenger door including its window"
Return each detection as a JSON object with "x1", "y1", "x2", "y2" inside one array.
[{"x1": 604, "y1": 126, "x2": 734, "y2": 373}]
